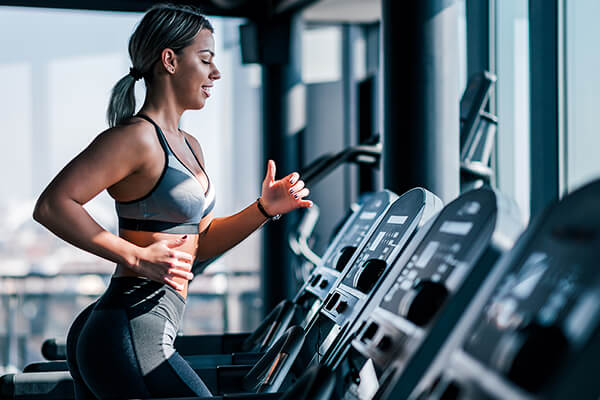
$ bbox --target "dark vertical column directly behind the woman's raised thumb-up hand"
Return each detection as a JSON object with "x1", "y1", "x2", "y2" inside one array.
[{"x1": 259, "y1": 17, "x2": 306, "y2": 312}]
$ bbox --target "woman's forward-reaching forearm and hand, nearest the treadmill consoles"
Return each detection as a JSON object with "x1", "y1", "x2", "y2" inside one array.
[{"x1": 196, "y1": 161, "x2": 312, "y2": 260}]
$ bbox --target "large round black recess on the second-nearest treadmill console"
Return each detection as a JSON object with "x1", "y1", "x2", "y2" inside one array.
[{"x1": 399, "y1": 280, "x2": 448, "y2": 326}]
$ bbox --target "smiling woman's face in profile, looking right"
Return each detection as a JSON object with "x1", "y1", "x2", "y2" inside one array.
[{"x1": 173, "y1": 29, "x2": 221, "y2": 110}]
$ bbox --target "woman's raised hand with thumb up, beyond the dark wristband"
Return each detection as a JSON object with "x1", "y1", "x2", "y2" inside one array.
[{"x1": 261, "y1": 160, "x2": 313, "y2": 215}]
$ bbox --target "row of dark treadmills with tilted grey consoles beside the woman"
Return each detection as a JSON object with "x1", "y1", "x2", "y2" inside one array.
[{"x1": 0, "y1": 181, "x2": 600, "y2": 400}]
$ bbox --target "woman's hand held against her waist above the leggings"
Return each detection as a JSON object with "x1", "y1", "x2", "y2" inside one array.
[{"x1": 135, "y1": 235, "x2": 194, "y2": 290}]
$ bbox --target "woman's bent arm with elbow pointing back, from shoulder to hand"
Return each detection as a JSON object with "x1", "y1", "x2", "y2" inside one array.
[{"x1": 33, "y1": 123, "x2": 191, "y2": 288}]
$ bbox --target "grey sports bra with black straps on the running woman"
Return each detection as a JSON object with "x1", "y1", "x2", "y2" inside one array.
[{"x1": 115, "y1": 114, "x2": 215, "y2": 234}]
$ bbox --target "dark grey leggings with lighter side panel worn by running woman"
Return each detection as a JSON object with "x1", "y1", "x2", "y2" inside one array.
[{"x1": 67, "y1": 277, "x2": 211, "y2": 400}]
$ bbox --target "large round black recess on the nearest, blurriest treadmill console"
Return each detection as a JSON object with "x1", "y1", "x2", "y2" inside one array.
[{"x1": 493, "y1": 322, "x2": 568, "y2": 392}]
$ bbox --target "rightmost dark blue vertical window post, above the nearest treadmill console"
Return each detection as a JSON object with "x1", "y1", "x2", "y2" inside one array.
[{"x1": 529, "y1": 0, "x2": 560, "y2": 217}]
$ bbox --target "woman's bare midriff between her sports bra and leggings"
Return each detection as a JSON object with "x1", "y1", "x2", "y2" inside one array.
[{"x1": 114, "y1": 229, "x2": 198, "y2": 298}]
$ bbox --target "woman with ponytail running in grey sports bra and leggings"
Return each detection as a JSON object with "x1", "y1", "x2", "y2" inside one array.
[{"x1": 34, "y1": 5, "x2": 312, "y2": 399}]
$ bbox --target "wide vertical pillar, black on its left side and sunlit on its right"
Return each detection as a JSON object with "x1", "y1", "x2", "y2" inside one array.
[{"x1": 382, "y1": 0, "x2": 460, "y2": 202}]
